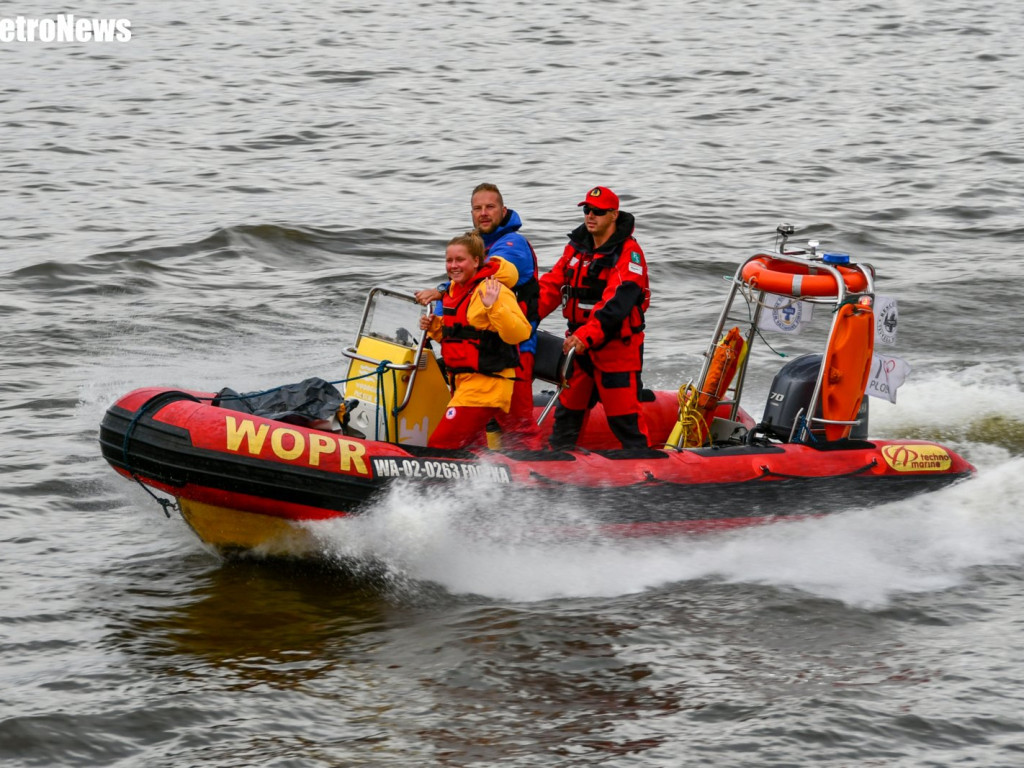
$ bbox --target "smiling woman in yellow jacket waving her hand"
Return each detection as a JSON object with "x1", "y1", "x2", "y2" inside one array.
[{"x1": 420, "y1": 232, "x2": 530, "y2": 449}]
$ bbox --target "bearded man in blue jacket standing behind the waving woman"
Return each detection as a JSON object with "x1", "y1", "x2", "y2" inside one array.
[{"x1": 416, "y1": 183, "x2": 543, "y2": 450}]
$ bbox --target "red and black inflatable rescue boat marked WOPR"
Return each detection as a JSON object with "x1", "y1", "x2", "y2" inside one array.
[{"x1": 100, "y1": 227, "x2": 974, "y2": 554}]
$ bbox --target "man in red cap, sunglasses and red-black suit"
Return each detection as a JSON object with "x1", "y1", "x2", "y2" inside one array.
[{"x1": 539, "y1": 186, "x2": 650, "y2": 450}]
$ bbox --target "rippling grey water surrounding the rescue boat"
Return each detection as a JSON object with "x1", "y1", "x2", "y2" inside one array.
[{"x1": 0, "y1": 0, "x2": 1024, "y2": 766}]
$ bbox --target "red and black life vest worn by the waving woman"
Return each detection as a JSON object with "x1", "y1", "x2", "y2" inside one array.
[{"x1": 441, "y1": 261, "x2": 519, "y2": 376}]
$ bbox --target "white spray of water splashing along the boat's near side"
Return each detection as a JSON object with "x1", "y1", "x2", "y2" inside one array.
[{"x1": 305, "y1": 460, "x2": 1024, "y2": 606}]
